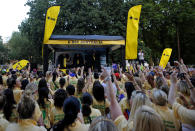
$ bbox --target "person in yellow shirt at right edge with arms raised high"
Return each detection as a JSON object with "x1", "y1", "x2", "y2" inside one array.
[{"x1": 168, "y1": 72, "x2": 195, "y2": 131}]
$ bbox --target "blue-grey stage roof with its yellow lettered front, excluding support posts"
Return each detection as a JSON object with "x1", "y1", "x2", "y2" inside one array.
[{"x1": 45, "y1": 35, "x2": 125, "y2": 51}]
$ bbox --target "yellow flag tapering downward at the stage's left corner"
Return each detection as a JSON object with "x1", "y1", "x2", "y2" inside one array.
[{"x1": 43, "y1": 6, "x2": 60, "y2": 43}]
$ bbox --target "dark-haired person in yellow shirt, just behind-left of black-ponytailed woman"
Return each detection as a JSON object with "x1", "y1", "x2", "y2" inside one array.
[{"x1": 50, "y1": 89, "x2": 68, "y2": 125}]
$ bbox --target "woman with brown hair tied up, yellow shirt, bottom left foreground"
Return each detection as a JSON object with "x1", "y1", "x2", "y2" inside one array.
[{"x1": 6, "y1": 95, "x2": 47, "y2": 131}]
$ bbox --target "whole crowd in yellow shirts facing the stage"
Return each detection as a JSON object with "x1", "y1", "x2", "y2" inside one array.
[{"x1": 0, "y1": 60, "x2": 195, "y2": 131}]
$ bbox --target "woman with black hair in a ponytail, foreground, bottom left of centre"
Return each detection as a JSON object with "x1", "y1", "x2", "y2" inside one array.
[{"x1": 51, "y1": 96, "x2": 89, "y2": 131}]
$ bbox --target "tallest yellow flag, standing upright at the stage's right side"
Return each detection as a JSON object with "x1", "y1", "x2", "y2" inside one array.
[{"x1": 125, "y1": 5, "x2": 142, "y2": 59}]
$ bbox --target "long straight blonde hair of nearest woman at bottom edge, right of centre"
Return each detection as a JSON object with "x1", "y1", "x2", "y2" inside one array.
[{"x1": 133, "y1": 106, "x2": 165, "y2": 131}]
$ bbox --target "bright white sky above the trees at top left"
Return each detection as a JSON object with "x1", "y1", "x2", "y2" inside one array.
[{"x1": 0, "y1": 0, "x2": 30, "y2": 43}]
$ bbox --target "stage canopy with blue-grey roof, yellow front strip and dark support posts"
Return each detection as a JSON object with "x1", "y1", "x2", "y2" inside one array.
[{"x1": 43, "y1": 35, "x2": 125, "y2": 72}]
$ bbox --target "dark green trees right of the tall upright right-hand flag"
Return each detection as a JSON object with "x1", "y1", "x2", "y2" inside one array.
[{"x1": 140, "y1": 0, "x2": 195, "y2": 64}]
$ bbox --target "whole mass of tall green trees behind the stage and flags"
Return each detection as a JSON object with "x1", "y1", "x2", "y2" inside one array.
[{"x1": 14, "y1": 0, "x2": 195, "y2": 64}]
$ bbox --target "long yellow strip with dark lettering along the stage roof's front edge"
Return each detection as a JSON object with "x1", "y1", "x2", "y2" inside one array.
[{"x1": 45, "y1": 40, "x2": 125, "y2": 45}]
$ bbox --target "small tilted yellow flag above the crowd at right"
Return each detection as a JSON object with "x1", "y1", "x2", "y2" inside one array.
[{"x1": 159, "y1": 48, "x2": 172, "y2": 69}]
